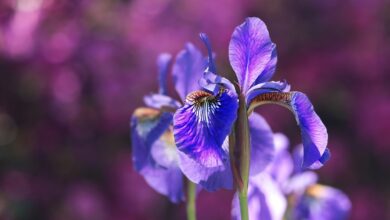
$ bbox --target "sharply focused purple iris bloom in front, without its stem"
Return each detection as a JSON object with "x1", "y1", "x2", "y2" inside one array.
[{"x1": 173, "y1": 18, "x2": 329, "y2": 190}]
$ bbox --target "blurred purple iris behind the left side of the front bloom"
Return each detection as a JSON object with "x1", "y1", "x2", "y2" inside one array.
[{"x1": 131, "y1": 43, "x2": 207, "y2": 203}]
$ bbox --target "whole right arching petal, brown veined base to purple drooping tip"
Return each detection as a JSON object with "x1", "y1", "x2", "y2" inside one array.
[{"x1": 248, "y1": 92, "x2": 330, "y2": 169}]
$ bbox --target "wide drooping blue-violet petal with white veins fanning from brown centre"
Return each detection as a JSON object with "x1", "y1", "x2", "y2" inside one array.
[{"x1": 173, "y1": 90, "x2": 238, "y2": 189}]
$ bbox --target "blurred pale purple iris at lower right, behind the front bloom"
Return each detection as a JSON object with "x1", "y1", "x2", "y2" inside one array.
[{"x1": 232, "y1": 134, "x2": 351, "y2": 220}]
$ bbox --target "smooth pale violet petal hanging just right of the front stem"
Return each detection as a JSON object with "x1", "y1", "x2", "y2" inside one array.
[{"x1": 249, "y1": 113, "x2": 275, "y2": 175}]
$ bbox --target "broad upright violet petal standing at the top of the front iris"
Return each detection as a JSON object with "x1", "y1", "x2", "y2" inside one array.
[{"x1": 229, "y1": 17, "x2": 276, "y2": 93}]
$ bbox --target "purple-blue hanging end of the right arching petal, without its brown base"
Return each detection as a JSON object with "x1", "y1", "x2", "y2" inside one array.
[{"x1": 290, "y1": 92, "x2": 330, "y2": 168}]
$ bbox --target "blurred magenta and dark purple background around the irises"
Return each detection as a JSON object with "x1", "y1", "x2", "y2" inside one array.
[{"x1": 0, "y1": 0, "x2": 390, "y2": 220}]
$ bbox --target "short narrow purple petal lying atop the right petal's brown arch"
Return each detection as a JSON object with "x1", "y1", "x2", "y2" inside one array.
[{"x1": 245, "y1": 81, "x2": 291, "y2": 103}]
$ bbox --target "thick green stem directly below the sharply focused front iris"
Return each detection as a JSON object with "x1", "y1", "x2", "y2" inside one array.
[{"x1": 236, "y1": 94, "x2": 250, "y2": 220}]
